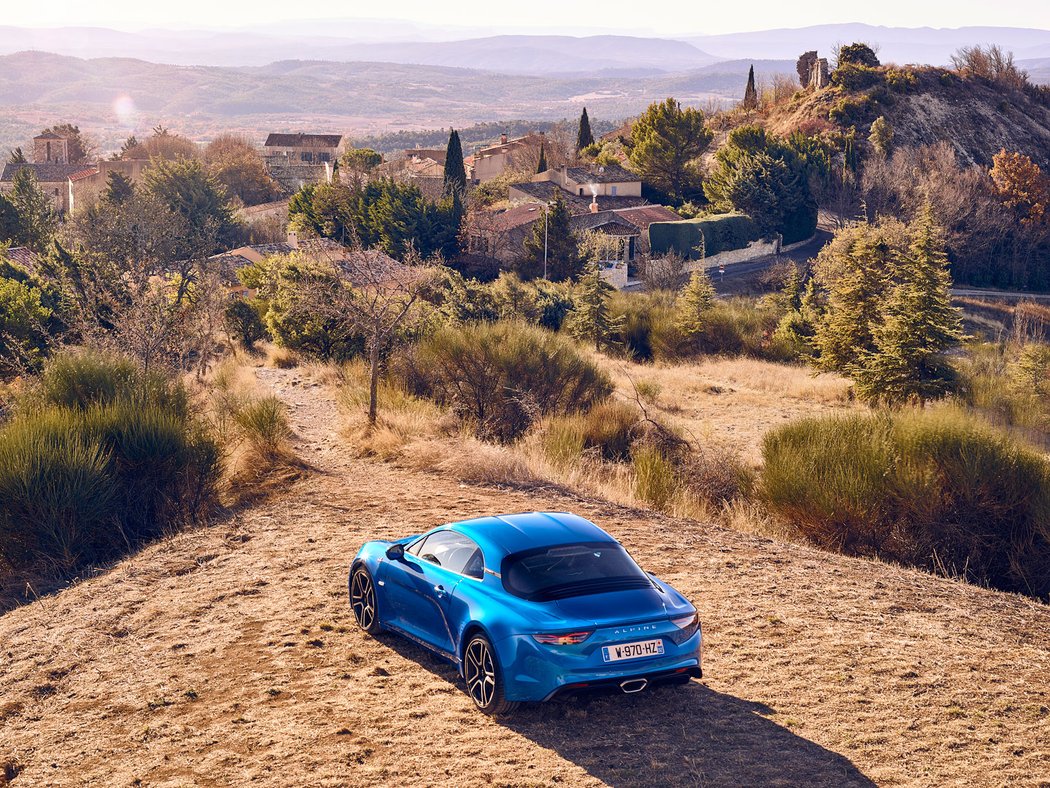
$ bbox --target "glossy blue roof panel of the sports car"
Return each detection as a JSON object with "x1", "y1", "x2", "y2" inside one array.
[{"x1": 448, "y1": 512, "x2": 615, "y2": 559}]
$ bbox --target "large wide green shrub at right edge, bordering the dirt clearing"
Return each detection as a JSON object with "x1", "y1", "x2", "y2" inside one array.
[{"x1": 762, "y1": 409, "x2": 1050, "y2": 598}]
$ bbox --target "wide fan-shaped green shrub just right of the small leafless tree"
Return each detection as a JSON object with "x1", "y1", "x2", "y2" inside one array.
[{"x1": 391, "y1": 322, "x2": 612, "y2": 441}]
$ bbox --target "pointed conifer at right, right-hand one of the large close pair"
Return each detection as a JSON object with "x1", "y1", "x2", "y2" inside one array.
[{"x1": 854, "y1": 200, "x2": 963, "y2": 405}]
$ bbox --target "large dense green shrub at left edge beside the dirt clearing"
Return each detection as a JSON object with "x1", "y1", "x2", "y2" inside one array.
[{"x1": 0, "y1": 353, "x2": 219, "y2": 568}]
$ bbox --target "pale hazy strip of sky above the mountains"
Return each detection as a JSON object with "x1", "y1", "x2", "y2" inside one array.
[{"x1": 12, "y1": 0, "x2": 1050, "y2": 36}]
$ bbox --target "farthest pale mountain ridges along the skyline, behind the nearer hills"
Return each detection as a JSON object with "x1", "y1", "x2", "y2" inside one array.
[{"x1": 0, "y1": 19, "x2": 1050, "y2": 70}]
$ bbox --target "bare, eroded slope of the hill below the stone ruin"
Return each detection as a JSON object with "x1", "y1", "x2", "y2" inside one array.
[{"x1": 765, "y1": 67, "x2": 1050, "y2": 168}]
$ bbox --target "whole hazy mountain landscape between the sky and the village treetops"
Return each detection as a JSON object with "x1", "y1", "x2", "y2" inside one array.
[{"x1": 0, "y1": 19, "x2": 1050, "y2": 151}]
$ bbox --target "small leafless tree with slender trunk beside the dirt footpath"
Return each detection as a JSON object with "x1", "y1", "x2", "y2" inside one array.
[{"x1": 303, "y1": 245, "x2": 438, "y2": 428}]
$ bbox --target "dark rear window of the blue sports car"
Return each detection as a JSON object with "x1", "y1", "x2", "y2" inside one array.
[{"x1": 500, "y1": 542, "x2": 651, "y2": 602}]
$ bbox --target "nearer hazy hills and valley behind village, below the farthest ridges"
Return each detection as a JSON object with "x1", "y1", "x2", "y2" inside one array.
[{"x1": 0, "y1": 51, "x2": 794, "y2": 150}]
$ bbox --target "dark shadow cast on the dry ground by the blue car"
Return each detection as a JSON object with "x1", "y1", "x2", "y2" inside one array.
[{"x1": 373, "y1": 634, "x2": 875, "y2": 788}]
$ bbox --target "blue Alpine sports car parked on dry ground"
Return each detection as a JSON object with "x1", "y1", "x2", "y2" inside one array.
[{"x1": 349, "y1": 512, "x2": 702, "y2": 714}]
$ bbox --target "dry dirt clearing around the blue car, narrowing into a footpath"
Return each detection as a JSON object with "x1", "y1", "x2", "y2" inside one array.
[{"x1": 0, "y1": 370, "x2": 1050, "y2": 786}]
